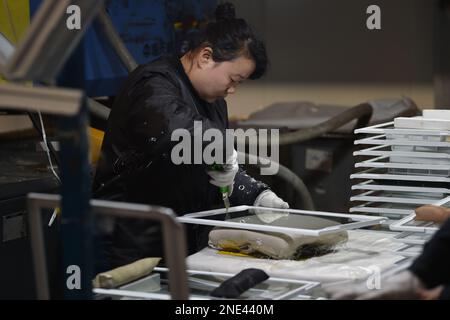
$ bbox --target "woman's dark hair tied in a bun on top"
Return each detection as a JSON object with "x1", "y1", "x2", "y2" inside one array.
[{"x1": 190, "y1": 3, "x2": 268, "y2": 79}]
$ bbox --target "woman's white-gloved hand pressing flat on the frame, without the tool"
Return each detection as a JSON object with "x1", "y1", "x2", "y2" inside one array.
[{"x1": 250, "y1": 190, "x2": 289, "y2": 223}]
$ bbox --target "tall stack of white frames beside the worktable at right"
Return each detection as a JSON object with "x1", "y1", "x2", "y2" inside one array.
[{"x1": 350, "y1": 110, "x2": 450, "y2": 219}]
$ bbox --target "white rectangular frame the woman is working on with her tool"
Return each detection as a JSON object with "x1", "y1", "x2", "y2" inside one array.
[{"x1": 177, "y1": 206, "x2": 386, "y2": 236}]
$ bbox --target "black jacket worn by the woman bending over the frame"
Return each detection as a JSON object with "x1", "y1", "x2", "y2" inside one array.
[{"x1": 93, "y1": 57, "x2": 268, "y2": 267}]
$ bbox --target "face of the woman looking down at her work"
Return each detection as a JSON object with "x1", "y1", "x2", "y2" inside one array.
[{"x1": 188, "y1": 47, "x2": 255, "y2": 103}]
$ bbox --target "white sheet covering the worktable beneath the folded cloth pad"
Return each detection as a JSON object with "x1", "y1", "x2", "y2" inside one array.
[{"x1": 187, "y1": 230, "x2": 404, "y2": 283}]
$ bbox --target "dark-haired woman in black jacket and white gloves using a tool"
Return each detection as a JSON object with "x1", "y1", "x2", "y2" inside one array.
[{"x1": 94, "y1": 3, "x2": 289, "y2": 269}]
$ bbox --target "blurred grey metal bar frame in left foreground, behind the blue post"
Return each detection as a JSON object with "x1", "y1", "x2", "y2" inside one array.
[{"x1": 27, "y1": 193, "x2": 189, "y2": 299}]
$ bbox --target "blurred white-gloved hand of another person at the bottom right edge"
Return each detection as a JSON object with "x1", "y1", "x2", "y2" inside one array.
[{"x1": 323, "y1": 270, "x2": 442, "y2": 300}]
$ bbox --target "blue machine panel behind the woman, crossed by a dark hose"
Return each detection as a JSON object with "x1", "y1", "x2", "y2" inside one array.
[{"x1": 30, "y1": 0, "x2": 217, "y2": 97}]
